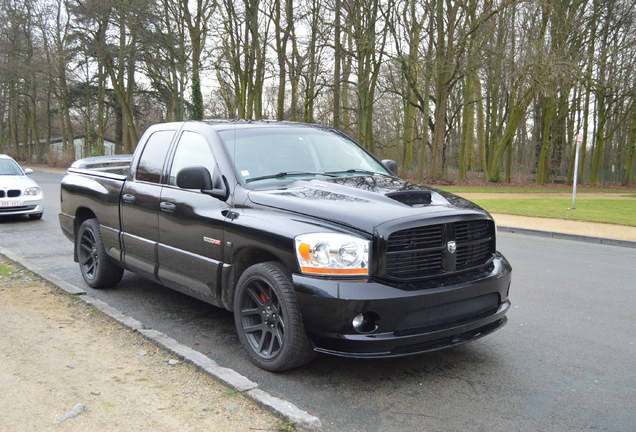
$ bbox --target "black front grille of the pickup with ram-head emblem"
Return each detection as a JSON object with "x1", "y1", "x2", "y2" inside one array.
[{"x1": 386, "y1": 220, "x2": 495, "y2": 280}]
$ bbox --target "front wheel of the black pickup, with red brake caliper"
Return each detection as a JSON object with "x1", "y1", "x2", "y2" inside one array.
[{"x1": 234, "y1": 262, "x2": 315, "y2": 372}]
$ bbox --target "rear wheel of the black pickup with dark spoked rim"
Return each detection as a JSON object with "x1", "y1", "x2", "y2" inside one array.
[{"x1": 75, "y1": 219, "x2": 124, "y2": 288}]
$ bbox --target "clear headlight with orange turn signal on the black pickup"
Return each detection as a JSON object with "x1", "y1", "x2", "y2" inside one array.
[{"x1": 295, "y1": 233, "x2": 370, "y2": 276}]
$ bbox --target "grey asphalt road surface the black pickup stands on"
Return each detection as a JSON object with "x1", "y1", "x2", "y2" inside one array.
[{"x1": 0, "y1": 172, "x2": 636, "y2": 431}]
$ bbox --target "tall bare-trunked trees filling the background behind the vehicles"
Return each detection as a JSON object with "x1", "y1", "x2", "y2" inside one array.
[{"x1": 0, "y1": 0, "x2": 636, "y2": 185}]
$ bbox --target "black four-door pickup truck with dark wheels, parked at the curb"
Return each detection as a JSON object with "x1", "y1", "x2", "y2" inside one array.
[{"x1": 59, "y1": 121, "x2": 511, "y2": 371}]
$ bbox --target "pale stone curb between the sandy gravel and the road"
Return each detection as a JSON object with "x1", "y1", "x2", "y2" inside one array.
[{"x1": 0, "y1": 246, "x2": 323, "y2": 431}]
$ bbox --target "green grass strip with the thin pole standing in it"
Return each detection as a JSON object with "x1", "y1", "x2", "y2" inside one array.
[{"x1": 474, "y1": 198, "x2": 636, "y2": 226}]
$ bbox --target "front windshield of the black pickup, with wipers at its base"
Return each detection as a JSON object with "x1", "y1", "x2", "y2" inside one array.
[{"x1": 219, "y1": 126, "x2": 391, "y2": 183}]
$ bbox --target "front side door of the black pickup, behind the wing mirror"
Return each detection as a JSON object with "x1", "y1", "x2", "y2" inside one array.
[{"x1": 158, "y1": 126, "x2": 228, "y2": 304}]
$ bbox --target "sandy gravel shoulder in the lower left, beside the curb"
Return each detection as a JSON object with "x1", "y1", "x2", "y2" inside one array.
[{"x1": 0, "y1": 257, "x2": 290, "y2": 431}]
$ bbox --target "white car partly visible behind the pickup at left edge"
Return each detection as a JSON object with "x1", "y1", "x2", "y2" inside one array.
[{"x1": 0, "y1": 154, "x2": 44, "y2": 219}]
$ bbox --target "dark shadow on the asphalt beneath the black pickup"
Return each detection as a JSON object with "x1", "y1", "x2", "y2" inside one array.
[{"x1": 97, "y1": 273, "x2": 505, "y2": 394}]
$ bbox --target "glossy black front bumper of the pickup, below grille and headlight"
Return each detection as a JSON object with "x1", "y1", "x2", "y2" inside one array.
[{"x1": 293, "y1": 254, "x2": 511, "y2": 358}]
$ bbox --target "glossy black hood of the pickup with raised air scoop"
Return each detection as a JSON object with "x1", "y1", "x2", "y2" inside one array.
[{"x1": 249, "y1": 176, "x2": 489, "y2": 233}]
